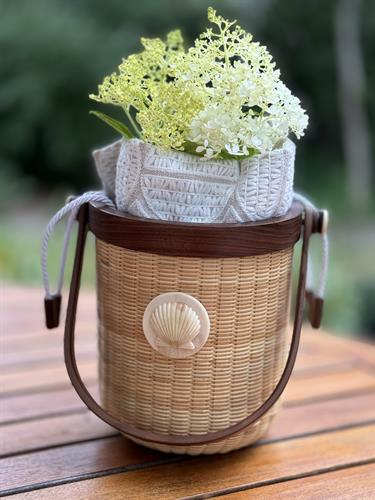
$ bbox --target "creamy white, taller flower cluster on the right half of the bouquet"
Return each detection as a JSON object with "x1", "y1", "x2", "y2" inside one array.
[{"x1": 185, "y1": 8, "x2": 308, "y2": 158}]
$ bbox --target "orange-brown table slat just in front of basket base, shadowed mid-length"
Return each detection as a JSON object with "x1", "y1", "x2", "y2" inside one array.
[{"x1": 4, "y1": 426, "x2": 375, "y2": 500}]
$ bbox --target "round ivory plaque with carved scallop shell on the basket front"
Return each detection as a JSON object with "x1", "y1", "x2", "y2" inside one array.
[{"x1": 143, "y1": 292, "x2": 210, "y2": 358}]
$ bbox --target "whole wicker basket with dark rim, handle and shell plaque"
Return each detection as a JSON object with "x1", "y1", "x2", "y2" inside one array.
[{"x1": 64, "y1": 203, "x2": 322, "y2": 455}]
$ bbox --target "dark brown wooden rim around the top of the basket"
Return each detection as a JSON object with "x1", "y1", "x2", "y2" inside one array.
[{"x1": 87, "y1": 202, "x2": 304, "y2": 258}]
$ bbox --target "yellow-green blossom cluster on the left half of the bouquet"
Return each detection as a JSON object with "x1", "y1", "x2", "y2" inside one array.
[{"x1": 90, "y1": 30, "x2": 201, "y2": 150}]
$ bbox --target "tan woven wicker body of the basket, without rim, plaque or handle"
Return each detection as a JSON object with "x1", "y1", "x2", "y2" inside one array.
[{"x1": 96, "y1": 240, "x2": 293, "y2": 454}]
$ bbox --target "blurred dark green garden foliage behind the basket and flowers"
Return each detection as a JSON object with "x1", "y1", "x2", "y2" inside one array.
[{"x1": 0, "y1": 0, "x2": 375, "y2": 334}]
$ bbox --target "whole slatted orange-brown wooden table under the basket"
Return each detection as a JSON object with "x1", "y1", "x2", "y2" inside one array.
[{"x1": 0, "y1": 286, "x2": 375, "y2": 500}]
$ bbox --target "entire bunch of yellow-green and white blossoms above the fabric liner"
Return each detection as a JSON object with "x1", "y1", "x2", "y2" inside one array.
[{"x1": 90, "y1": 8, "x2": 308, "y2": 158}]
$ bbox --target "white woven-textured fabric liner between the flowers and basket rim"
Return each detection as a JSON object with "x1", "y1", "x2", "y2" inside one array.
[{"x1": 93, "y1": 139, "x2": 295, "y2": 223}]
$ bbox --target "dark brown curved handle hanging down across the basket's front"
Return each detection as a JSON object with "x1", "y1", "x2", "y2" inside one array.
[{"x1": 64, "y1": 205, "x2": 316, "y2": 446}]
